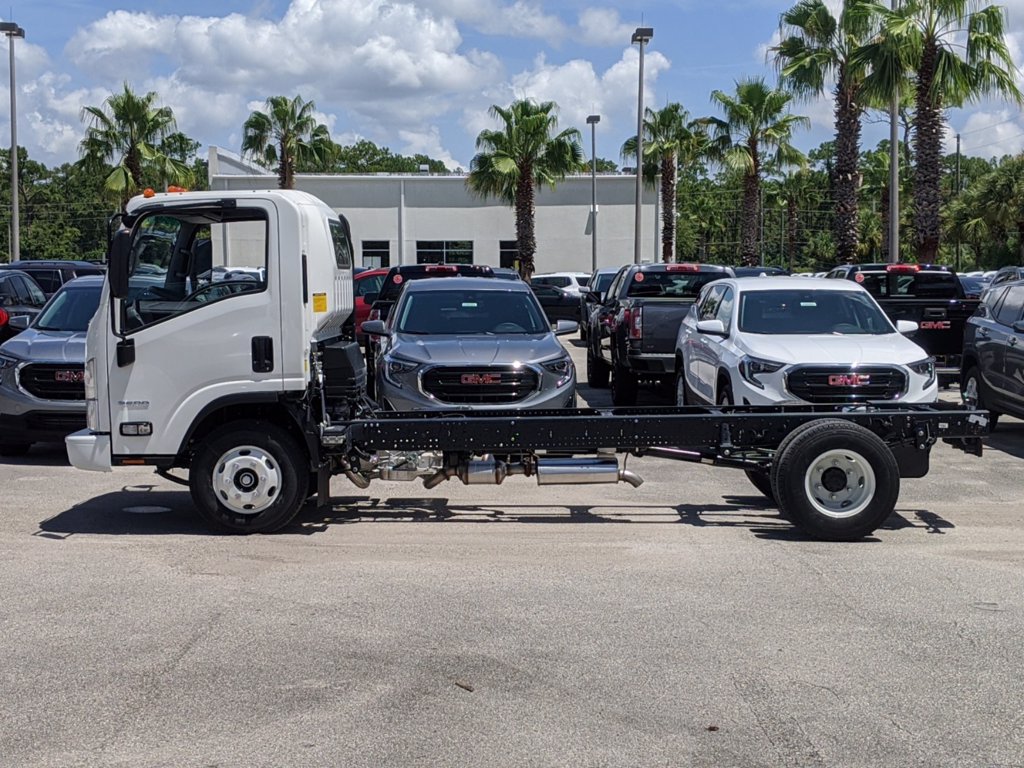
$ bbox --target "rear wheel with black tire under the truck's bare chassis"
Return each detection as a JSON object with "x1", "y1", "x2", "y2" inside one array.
[{"x1": 772, "y1": 419, "x2": 900, "y2": 542}]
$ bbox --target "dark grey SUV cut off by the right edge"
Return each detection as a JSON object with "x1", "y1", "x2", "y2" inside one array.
[{"x1": 961, "y1": 281, "x2": 1024, "y2": 429}]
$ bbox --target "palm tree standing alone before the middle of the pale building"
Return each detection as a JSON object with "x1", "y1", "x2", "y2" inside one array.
[{"x1": 466, "y1": 99, "x2": 584, "y2": 281}]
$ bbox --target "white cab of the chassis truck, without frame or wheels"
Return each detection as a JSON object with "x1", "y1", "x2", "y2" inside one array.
[{"x1": 67, "y1": 190, "x2": 353, "y2": 487}]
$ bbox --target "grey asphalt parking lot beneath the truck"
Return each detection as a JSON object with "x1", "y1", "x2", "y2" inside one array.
[{"x1": 0, "y1": 343, "x2": 1024, "y2": 768}]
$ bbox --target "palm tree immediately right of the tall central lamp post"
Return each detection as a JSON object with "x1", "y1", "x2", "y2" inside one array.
[{"x1": 622, "y1": 103, "x2": 711, "y2": 262}]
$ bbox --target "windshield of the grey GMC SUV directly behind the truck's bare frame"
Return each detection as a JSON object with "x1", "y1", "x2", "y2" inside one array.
[{"x1": 396, "y1": 290, "x2": 550, "y2": 336}]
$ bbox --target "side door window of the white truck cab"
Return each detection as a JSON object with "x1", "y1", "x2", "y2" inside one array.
[{"x1": 120, "y1": 209, "x2": 268, "y2": 334}]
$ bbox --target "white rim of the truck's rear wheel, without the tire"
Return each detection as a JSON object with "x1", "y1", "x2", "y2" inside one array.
[{"x1": 804, "y1": 450, "x2": 877, "y2": 519}]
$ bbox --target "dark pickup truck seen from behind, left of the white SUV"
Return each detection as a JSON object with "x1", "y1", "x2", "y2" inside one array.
[{"x1": 584, "y1": 264, "x2": 733, "y2": 406}]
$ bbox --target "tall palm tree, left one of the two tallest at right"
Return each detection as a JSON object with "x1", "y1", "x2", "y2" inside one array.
[{"x1": 772, "y1": 0, "x2": 873, "y2": 263}]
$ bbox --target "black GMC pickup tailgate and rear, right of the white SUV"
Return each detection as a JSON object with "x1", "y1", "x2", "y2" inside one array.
[{"x1": 825, "y1": 264, "x2": 981, "y2": 383}]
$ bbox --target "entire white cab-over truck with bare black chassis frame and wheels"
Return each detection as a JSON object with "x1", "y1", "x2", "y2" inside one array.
[{"x1": 67, "y1": 190, "x2": 987, "y2": 540}]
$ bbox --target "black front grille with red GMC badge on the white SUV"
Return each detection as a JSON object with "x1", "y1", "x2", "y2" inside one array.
[{"x1": 786, "y1": 366, "x2": 906, "y2": 402}]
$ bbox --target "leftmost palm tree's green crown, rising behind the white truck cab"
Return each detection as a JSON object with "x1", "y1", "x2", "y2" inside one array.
[{"x1": 79, "y1": 83, "x2": 190, "y2": 207}]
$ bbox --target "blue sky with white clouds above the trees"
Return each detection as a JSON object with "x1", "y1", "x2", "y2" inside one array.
[{"x1": 0, "y1": 0, "x2": 1024, "y2": 168}]
